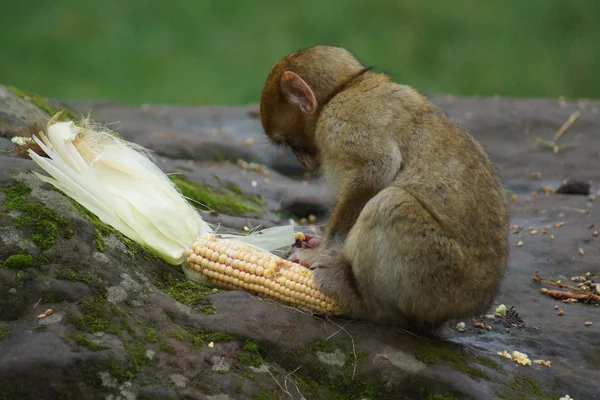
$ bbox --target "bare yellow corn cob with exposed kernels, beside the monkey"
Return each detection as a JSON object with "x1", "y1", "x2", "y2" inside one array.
[{"x1": 186, "y1": 234, "x2": 340, "y2": 314}]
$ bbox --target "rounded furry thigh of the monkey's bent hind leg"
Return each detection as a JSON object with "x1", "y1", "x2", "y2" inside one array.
[{"x1": 340, "y1": 186, "x2": 494, "y2": 326}]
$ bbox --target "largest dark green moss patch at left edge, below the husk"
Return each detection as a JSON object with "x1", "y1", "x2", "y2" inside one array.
[{"x1": 4, "y1": 183, "x2": 72, "y2": 250}]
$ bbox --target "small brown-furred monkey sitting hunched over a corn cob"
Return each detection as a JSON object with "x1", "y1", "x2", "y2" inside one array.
[{"x1": 259, "y1": 45, "x2": 509, "y2": 332}]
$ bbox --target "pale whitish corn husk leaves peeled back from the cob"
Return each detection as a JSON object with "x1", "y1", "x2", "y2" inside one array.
[{"x1": 29, "y1": 117, "x2": 294, "y2": 265}]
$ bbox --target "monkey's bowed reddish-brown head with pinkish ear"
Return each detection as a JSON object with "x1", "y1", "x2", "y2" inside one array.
[{"x1": 260, "y1": 46, "x2": 365, "y2": 171}]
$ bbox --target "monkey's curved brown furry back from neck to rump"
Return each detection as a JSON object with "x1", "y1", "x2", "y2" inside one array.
[{"x1": 321, "y1": 73, "x2": 509, "y2": 271}]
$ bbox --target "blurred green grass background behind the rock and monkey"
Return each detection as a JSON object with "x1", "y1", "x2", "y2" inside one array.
[{"x1": 0, "y1": 0, "x2": 600, "y2": 105}]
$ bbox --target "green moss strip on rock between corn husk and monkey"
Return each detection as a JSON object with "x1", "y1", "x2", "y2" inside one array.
[{"x1": 169, "y1": 175, "x2": 261, "y2": 215}]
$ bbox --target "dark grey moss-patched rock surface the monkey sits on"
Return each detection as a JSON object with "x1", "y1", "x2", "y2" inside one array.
[{"x1": 0, "y1": 86, "x2": 600, "y2": 400}]
